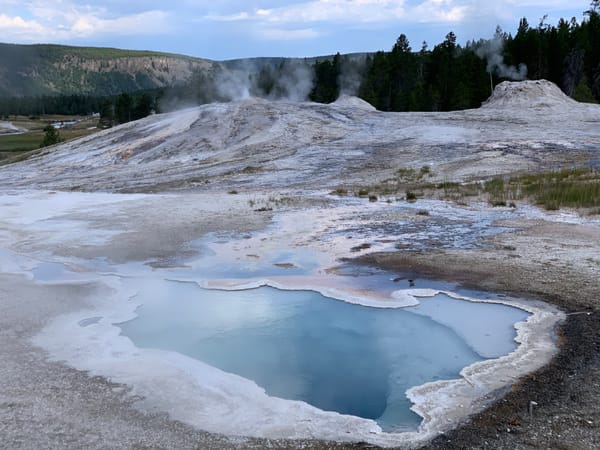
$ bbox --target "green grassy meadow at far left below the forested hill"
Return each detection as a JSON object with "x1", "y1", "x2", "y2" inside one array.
[{"x1": 0, "y1": 116, "x2": 99, "y2": 164}]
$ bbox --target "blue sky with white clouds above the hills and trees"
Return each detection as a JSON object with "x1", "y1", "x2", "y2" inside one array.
[{"x1": 0, "y1": 0, "x2": 590, "y2": 60}]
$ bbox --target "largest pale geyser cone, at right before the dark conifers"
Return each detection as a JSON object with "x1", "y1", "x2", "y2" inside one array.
[{"x1": 482, "y1": 80, "x2": 579, "y2": 109}]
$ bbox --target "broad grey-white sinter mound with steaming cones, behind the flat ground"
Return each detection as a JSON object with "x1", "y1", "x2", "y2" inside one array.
[{"x1": 0, "y1": 81, "x2": 600, "y2": 192}]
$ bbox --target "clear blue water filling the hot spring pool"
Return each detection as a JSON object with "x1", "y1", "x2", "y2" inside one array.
[{"x1": 119, "y1": 280, "x2": 526, "y2": 431}]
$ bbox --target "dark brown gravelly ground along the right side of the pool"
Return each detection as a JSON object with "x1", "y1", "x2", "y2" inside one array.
[{"x1": 365, "y1": 217, "x2": 600, "y2": 449}]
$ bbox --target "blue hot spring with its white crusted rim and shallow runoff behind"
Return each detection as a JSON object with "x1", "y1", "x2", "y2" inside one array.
[{"x1": 7, "y1": 196, "x2": 562, "y2": 447}]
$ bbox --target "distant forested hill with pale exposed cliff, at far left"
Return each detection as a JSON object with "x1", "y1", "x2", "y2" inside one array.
[{"x1": 0, "y1": 44, "x2": 213, "y2": 97}]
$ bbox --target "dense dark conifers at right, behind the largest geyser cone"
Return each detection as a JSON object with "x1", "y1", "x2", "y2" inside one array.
[{"x1": 352, "y1": 0, "x2": 600, "y2": 111}]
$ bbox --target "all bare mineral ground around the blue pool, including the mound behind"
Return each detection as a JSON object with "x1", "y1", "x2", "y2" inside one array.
[{"x1": 0, "y1": 81, "x2": 600, "y2": 448}]
